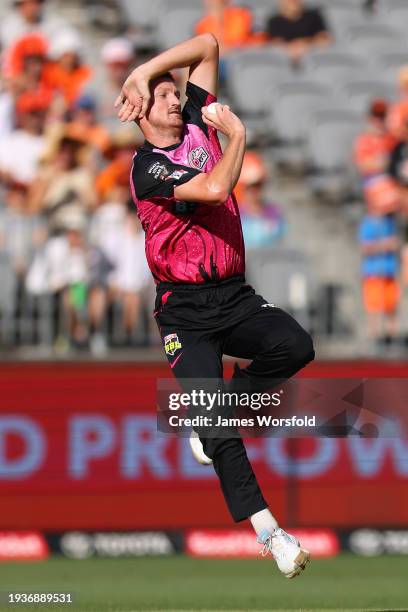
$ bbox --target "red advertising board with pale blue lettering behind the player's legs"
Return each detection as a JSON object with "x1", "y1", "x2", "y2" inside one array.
[{"x1": 0, "y1": 364, "x2": 408, "y2": 533}]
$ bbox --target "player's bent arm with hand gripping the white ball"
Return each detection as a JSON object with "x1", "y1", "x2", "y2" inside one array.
[{"x1": 174, "y1": 105, "x2": 245, "y2": 206}]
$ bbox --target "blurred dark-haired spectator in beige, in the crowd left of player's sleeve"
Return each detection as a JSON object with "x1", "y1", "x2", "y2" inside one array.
[{"x1": 29, "y1": 126, "x2": 96, "y2": 233}]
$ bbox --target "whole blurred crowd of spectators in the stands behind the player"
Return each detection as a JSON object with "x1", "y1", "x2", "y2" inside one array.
[{"x1": 0, "y1": 0, "x2": 408, "y2": 355}]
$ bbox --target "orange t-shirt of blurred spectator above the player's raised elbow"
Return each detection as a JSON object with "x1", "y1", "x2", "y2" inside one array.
[{"x1": 196, "y1": 6, "x2": 252, "y2": 49}]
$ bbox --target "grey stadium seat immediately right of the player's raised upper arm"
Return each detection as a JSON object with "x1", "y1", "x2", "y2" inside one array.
[{"x1": 227, "y1": 47, "x2": 291, "y2": 114}]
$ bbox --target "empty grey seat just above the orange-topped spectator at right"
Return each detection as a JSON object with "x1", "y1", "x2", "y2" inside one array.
[{"x1": 341, "y1": 79, "x2": 397, "y2": 113}]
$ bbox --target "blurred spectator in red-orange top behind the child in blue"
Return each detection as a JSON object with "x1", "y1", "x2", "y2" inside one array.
[{"x1": 354, "y1": 99, "x2": 395, "y2": 178}]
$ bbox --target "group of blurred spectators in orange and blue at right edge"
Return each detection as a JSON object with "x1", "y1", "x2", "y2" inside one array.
[{"x1": 354, "y1": 67, "x2": 408, "y2": 342}]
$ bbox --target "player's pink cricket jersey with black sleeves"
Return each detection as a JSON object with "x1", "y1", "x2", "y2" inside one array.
[{"x1": 131, "y1": 82, "x2": 245, "y2": 283}]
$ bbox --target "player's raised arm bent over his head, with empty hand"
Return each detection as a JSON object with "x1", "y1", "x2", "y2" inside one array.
[{"x1": 115, "y1": 34, "x2": 219, "y2": 121}]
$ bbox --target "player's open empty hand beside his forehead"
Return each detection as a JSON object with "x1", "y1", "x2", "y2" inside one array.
[{"x1": 115, "y1": 67, "x2": 150, "y2": 122}]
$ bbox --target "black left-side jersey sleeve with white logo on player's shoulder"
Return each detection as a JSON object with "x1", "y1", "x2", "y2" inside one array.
[{"x1": 131, "y1": 153, "x2": 200, "y2": 200}]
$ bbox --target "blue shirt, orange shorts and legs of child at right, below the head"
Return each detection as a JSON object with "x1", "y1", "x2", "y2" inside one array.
[{"x1": 359, "y1": 211, "x2": 400, "y2": 341}]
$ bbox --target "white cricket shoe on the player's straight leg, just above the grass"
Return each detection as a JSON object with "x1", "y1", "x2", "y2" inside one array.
[{"x1": 256, "y1": 527, "x2": 310, "y2": 578}]
